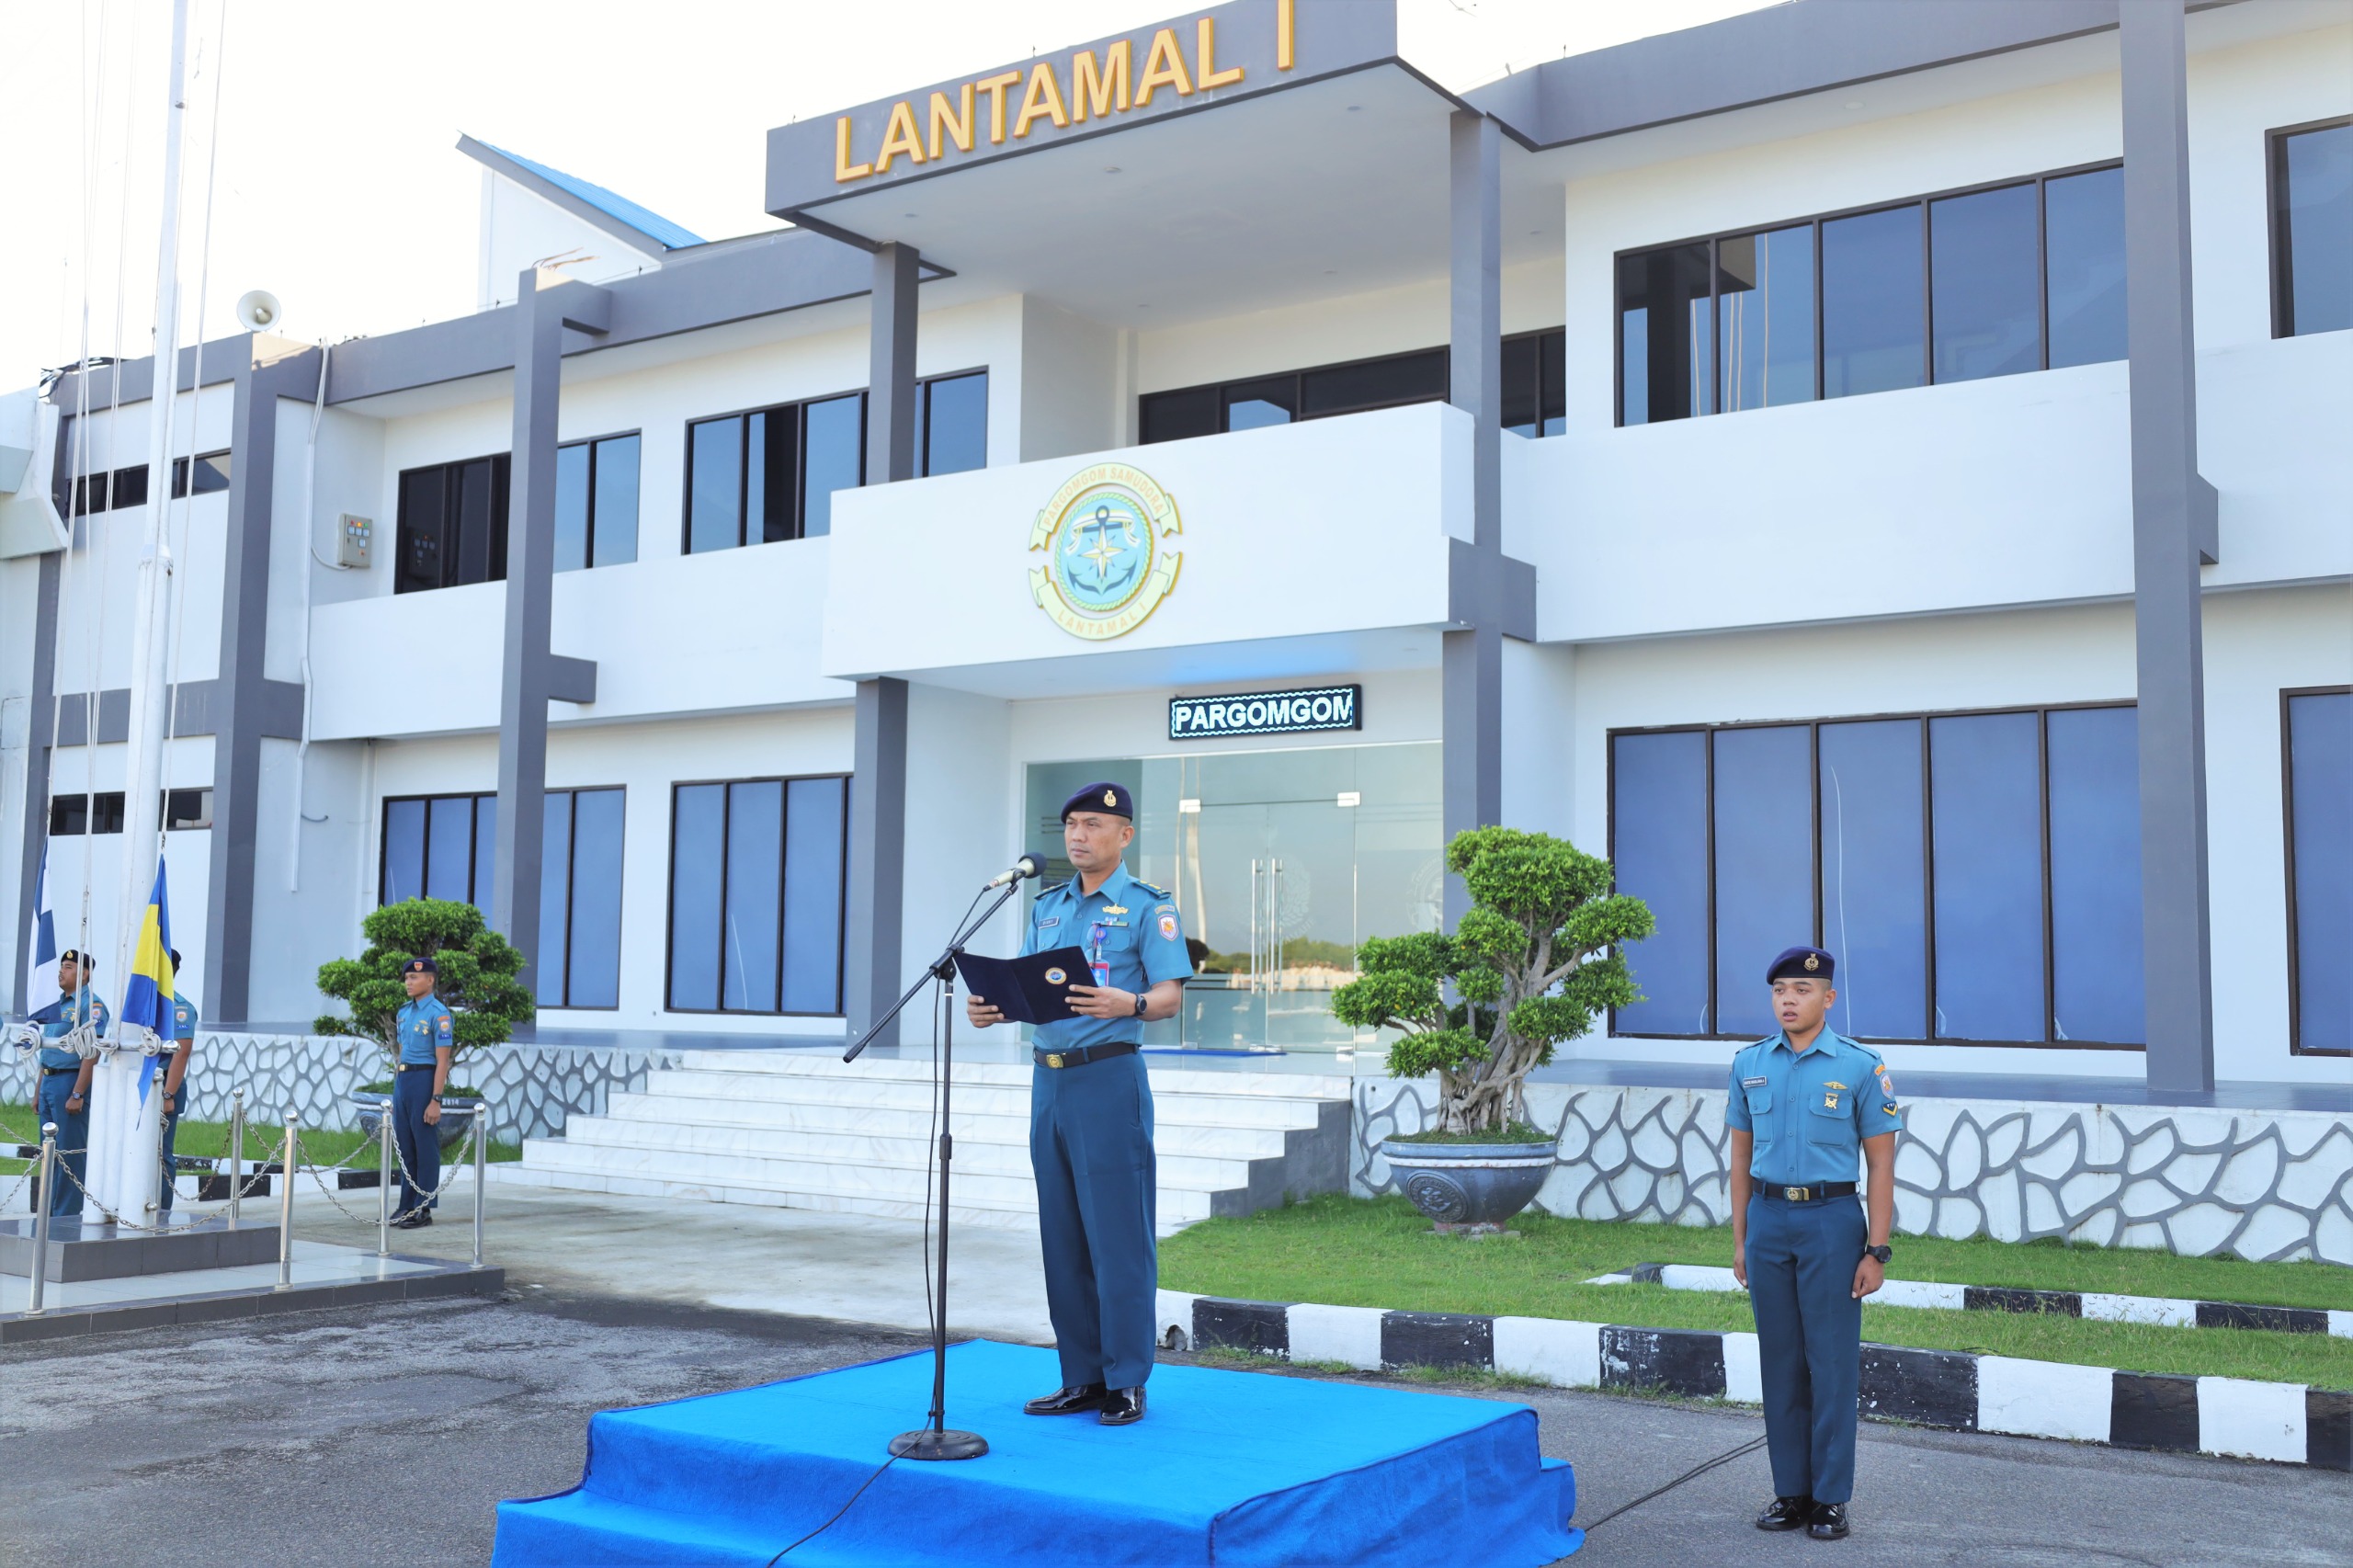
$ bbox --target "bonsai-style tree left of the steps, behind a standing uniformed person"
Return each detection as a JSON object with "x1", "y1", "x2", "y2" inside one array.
[{"x1": 311, "y1": 900, "x2": 539, "y2": 1149}]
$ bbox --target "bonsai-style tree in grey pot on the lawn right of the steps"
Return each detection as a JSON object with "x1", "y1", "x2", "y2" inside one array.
[{"x1": 1332, "y1": 826, "x2": 1652, "y2": 1233}]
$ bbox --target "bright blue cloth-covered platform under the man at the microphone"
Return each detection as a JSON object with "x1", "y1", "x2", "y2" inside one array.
[{"x1": 492, "y1": 1340, "x2": 1584, "y2": 1568}]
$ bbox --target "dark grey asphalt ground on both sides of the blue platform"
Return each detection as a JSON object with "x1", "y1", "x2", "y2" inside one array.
[{"x1": 0, "y1": 1288, "x2": 2353, "y2": 1568}]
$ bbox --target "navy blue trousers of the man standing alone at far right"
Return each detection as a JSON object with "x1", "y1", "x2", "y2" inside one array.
[{"x1": 1748, "y1": 1199, "x2": 1866, "y2": 1502}]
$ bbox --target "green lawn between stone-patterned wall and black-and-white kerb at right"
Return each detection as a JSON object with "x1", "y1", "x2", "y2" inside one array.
[{"x1": 1160, "y1": 1196, "x2": 2353, "y2": 1389}]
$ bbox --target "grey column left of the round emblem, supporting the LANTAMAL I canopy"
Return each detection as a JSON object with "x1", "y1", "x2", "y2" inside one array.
[{"x1": 842, "y1": 244, "x2": 917, "y2": 1045}]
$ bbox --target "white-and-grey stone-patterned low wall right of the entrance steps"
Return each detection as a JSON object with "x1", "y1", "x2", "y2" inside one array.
[{"x1": 1348, "y1": 1078, "x2": 2353, "y2": 1265}]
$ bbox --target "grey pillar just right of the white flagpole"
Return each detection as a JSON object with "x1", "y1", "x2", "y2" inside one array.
[{"x1": 200, "y1": 336, "x2": 320, "y2": 1022}]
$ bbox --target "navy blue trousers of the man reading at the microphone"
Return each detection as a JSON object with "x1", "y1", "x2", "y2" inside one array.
[{"x1": 1030, "y1": 1055, "x2": 1160, "y2": 1389}]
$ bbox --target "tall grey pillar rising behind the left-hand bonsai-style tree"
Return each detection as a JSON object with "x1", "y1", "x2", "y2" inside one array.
[{"x1": 489, "y1": 268, "x2": 609, "y2": 986}]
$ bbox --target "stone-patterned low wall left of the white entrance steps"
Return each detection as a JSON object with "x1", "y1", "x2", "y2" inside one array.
[{"x1": 0, "y1": 1034, "x2": 677, "y2": 1142}]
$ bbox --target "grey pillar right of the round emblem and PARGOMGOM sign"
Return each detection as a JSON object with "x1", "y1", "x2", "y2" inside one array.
[{"x1": 1440, "y1": 110, "x2": 1504, "y2": 927}]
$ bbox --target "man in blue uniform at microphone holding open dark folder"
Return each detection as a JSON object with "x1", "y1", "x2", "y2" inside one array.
[{"x1": 965, "y1": 784, "x2": 1193, "y2": 1426}]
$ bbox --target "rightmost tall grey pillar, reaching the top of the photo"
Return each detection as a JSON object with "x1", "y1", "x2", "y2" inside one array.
[{"x1": 2120, "y1": 0, "x2": 2217, "y2": 1093}]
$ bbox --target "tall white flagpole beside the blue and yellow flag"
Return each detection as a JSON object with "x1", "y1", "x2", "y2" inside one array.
[{"x1": 89, "y1": 0, "x2": 202, "y2": 1229}]
